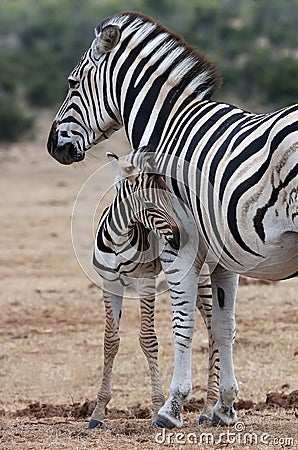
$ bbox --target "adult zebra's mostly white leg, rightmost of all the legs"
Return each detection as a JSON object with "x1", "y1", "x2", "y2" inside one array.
[{"x1": 211, "y1": 266, "x2": 239, "y2": 425}]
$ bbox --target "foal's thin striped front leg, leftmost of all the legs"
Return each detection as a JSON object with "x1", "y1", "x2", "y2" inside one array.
[{"x1": 88, "y1": 287, "x2": 123, "y2": 428}]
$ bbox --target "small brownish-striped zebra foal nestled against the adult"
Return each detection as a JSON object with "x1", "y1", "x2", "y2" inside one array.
[{"x1": 89, "y1": 147, "x2": 219, "y2": 428}]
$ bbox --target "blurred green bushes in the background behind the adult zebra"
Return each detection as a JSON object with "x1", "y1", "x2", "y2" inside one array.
[{"x1": 0, "y1": 0, "x2": 298, "y2": 139}]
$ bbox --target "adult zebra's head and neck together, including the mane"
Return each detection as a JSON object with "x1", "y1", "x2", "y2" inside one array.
[{"x1": 48, "y1": 12, "x2": 220, "y2": 164}]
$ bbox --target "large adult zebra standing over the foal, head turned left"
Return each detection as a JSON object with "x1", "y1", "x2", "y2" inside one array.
[{"x1": 48, "y1": 9, "x2": 298, "y2": 427}]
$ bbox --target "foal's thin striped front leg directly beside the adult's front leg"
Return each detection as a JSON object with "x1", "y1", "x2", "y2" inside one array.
[{"x1": 137, "y1": 277, "x2": 165, "y2": 420}]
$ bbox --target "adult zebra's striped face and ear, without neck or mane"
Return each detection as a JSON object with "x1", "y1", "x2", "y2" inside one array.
[{"x1": 47, "y1": 20, "x2": 122, "y2": 165}]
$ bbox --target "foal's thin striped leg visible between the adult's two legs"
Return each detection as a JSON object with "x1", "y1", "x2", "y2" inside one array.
[{"x1": 197, "y1": 275, "x2": 220, "y2": 425}]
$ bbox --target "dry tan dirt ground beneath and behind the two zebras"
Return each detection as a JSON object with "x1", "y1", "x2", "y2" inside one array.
[{"x1": 0, "y1": 113, "x2": 298, "y2": 450}]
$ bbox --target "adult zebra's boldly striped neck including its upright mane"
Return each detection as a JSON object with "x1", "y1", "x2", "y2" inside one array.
[{"x1": 97, "y1": 13, "x2": 220, "y2": 148}]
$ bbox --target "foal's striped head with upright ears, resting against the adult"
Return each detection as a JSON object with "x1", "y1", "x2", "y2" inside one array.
[{"x1": 107, "y1": 147, "x2": 187, "y2": 250}]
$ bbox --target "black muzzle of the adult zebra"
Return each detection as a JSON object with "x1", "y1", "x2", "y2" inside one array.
[{"x1": 47, "y1": 121, "x2": 85, "y2": 165}]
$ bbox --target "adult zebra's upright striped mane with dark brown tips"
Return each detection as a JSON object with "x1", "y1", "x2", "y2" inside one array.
[{"x1": 96, "y1": 12, "x2": 221, "y2": 100}]
